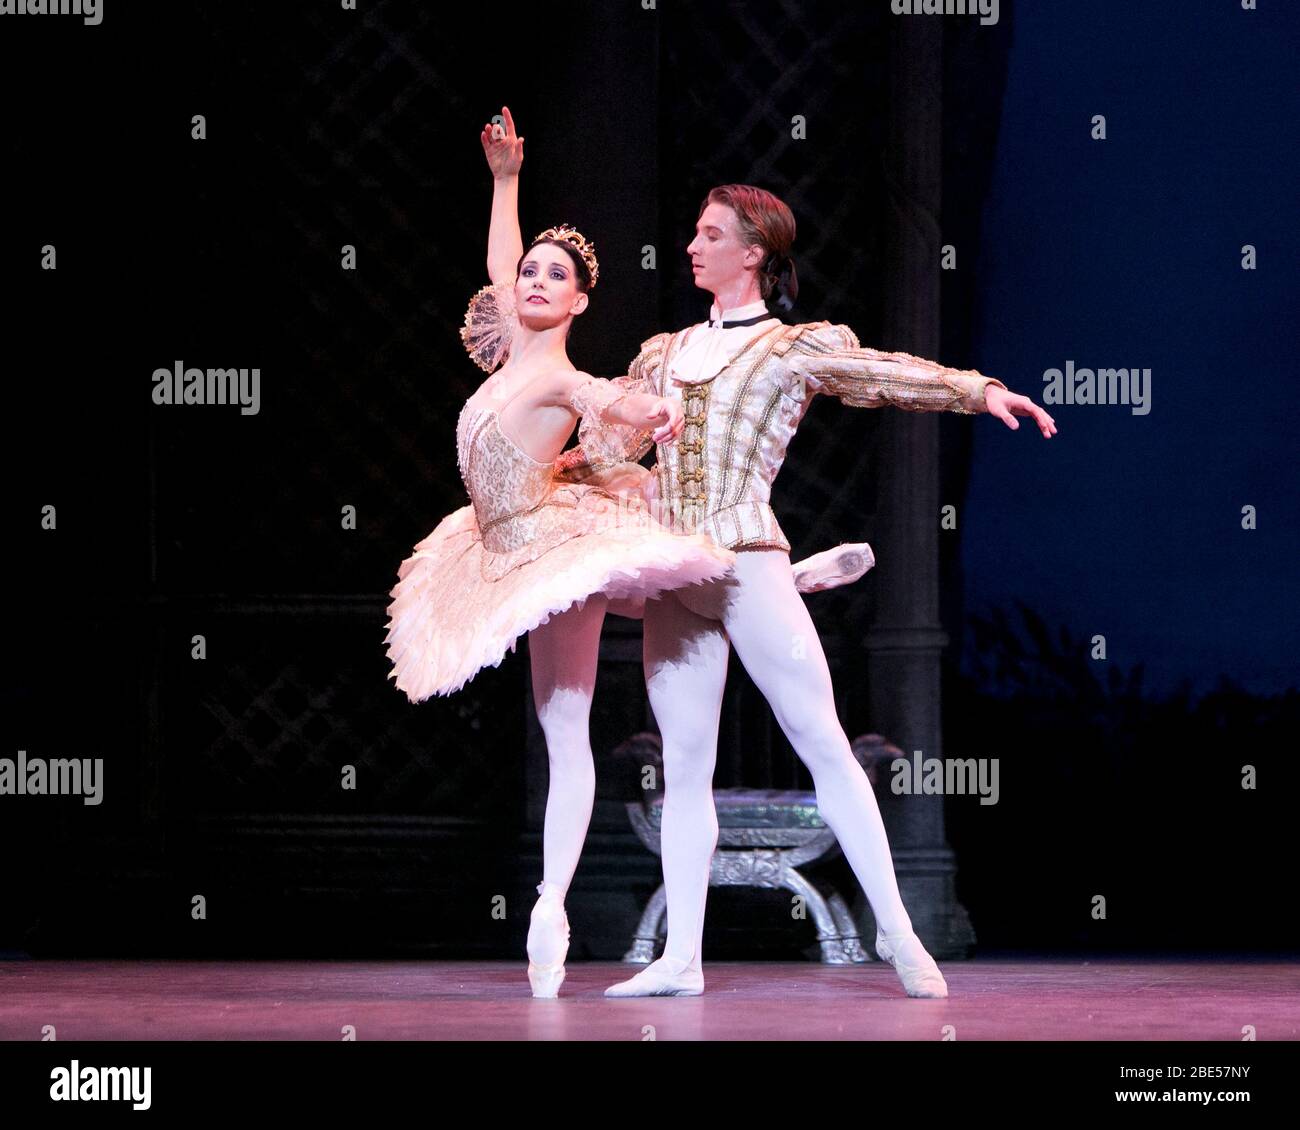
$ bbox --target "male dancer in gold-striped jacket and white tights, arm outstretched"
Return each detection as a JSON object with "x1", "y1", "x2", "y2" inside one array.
[{"x1": 559, "y1": 185, "x2": 1056, "y2": 997}]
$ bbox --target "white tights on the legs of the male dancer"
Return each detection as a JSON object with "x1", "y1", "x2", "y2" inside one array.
[{"x1": 645, "y1": 550, "x2": 911, "y2": 970}]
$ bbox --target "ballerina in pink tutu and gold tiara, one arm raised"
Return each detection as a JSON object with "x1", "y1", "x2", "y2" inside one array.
[{"x1": 385, "y1": 111, "x2": 735, "y2": 997}]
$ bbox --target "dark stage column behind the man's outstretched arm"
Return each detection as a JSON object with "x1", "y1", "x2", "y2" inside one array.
[{"x1": 858, "y1": 18, "x2": 975, "y2": 957}]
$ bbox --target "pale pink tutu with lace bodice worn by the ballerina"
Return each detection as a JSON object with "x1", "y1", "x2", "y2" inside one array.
[{"x1": 385, "y1": 390, "x2": 735, "y2": 702}]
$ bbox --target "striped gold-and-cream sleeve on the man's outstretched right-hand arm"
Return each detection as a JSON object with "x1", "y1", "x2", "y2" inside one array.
[{"x1": 788, "y1": 321, "x2": 1006, "y2": 416}]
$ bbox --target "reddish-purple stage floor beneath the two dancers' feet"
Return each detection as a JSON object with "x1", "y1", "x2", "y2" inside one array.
[{"x1": 0, "y1": 956, "x2": 1300, "y2": 1040}]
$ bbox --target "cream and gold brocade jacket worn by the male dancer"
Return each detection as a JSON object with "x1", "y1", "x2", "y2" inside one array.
[{"x1": 556, "y1": 321, "x2": 1006, "y2": 551}]
